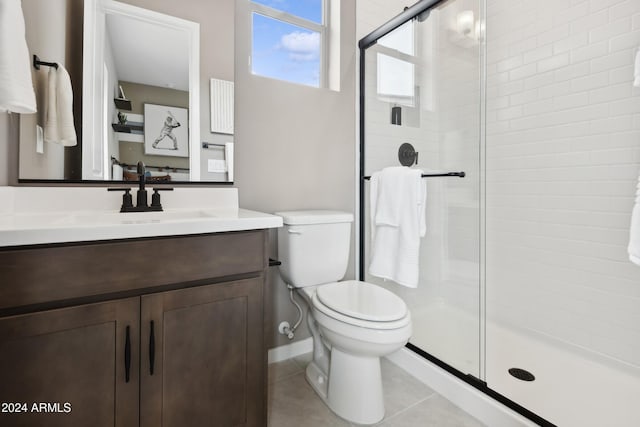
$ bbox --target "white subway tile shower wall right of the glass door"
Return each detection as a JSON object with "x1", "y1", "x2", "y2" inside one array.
[{"x1": 486, "y1": 0, "x2": 640, "y2": 368}]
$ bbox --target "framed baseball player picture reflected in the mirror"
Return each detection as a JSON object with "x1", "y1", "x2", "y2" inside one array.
[{"x1": 144, "y1": 104, "x2": 189, "y2": 157}]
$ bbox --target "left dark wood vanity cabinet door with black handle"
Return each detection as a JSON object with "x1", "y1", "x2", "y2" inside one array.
[{"x1": 0, "y1": 298, "x2": 140, "y2": 427}]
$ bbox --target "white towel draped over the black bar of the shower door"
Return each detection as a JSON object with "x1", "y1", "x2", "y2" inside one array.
[{"x1": 369, "y1": 167, "x2": 427, "y2": 288}]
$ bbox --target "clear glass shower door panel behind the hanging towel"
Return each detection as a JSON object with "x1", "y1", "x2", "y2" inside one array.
[{"x1": 361, "y1": 0, "x2": 482, "y2": 377}]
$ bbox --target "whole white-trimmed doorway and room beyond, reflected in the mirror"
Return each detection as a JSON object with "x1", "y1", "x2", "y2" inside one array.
[{"x1": 82, "y1": 0, "x2": 200, "y2": 181}]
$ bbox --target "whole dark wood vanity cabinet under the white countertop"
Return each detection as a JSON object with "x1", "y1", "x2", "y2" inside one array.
[{"x1": 0, "y1": 231, "x2": 268, "y2": 427}]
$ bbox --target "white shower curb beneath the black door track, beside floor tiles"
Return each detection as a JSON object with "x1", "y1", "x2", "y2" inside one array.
[{"x1": 387, "y1": 348, "x2": 537, "y2": 427}]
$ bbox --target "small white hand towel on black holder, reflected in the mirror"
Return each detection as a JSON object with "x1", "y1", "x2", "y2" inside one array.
[{"x1": 44, "y1": 64, "x2": 78, "y2": 147}]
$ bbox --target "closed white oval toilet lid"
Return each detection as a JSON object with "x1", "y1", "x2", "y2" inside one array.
[{"x1": 316, "y1": 280, "x2": 407, "y2": 322}]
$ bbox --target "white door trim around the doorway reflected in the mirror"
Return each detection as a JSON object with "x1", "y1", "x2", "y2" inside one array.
[{"x1": 82, "y1": 0, "x2": 200, "y2": 184}]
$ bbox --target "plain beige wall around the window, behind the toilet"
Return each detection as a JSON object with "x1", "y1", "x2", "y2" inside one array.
[{"x1": 235, "y1": 0, "x2": 356, "y2": 346}]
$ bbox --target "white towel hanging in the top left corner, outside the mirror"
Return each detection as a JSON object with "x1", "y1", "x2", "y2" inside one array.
[{"x1": 0, "y1": 0, "x2": 36, "y2": 113}]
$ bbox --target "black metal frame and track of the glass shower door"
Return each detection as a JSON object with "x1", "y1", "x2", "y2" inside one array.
[{"x1": 357, "y1": 0, "x2": 555, "y2": 427}]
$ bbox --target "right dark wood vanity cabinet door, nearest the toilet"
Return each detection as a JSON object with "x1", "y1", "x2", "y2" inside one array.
[{"x1": 140, "y1": 277, "x2": 266, "y2": 427}]
